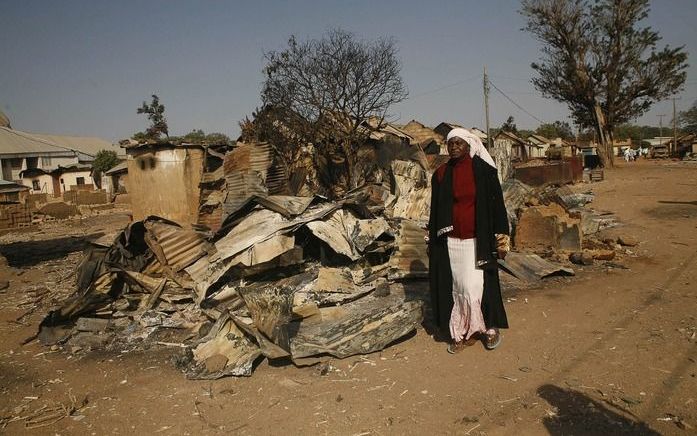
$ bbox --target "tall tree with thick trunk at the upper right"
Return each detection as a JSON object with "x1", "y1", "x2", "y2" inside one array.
[{"x1": 520, "y1": 0, "x2": 687, "y2": 166}]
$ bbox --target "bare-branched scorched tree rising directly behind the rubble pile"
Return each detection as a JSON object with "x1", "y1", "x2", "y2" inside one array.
[{"x1": 260, "y1": 29, "x2": 407, "y2": 195}]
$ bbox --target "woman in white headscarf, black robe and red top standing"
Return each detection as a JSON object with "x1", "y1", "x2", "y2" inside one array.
[{"x1": 428, "y1": 128, "x2": 509, "y2": 353}]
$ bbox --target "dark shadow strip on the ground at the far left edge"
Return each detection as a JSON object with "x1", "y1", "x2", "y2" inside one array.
[{"x1": 0, "y1": 232, "x2": 104, "y2": 268}]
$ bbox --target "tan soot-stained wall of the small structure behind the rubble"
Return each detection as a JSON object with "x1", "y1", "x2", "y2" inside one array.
[{"x1": 127, "y1": 148, "x2": 204, "y2": 226}]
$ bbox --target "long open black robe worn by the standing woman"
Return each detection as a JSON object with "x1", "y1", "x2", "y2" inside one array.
[{"x1": 428, "y1": 156, "x2": 509, "y2": 333}]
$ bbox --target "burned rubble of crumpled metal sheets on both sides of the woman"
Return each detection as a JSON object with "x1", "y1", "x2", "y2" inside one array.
[{"x1": 38, "y1": 141, "x2": 628, "y2": 379}]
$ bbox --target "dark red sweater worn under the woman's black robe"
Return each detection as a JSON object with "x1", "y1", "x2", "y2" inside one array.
[{"x1": 437, "y1": 154, "x2": 477, "y2": 239}]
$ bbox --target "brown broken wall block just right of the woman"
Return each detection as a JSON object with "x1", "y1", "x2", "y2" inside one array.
[{"x1": 514, "y1": 203, "x2": 583, "y2": 251}]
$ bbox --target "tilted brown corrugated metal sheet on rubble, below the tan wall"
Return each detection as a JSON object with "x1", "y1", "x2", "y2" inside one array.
[{"x1": 145, "y1": 221, "x2": 211, "y2": 272}]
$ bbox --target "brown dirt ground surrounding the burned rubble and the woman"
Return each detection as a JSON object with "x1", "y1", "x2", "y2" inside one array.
[{"x1": 0, "y1": 161, "x2": 697, "y2": 435}]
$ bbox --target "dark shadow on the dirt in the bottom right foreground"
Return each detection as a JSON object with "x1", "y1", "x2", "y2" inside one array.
[{"x1": 537, "y1": 384, "x2": 660, "y2": 435}]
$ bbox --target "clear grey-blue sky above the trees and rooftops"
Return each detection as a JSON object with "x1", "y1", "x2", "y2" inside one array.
[{"x1": 0, "y1": 0, "x2": 697, "y2": 141}]
